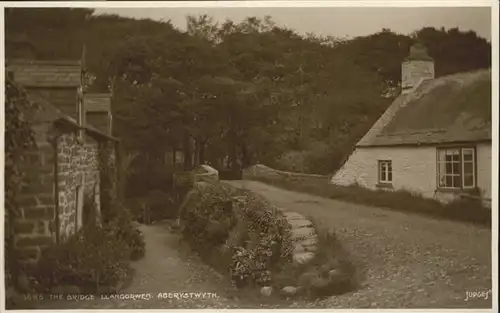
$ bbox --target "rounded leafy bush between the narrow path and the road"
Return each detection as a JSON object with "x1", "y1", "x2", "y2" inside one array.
[{"x1": 180, "y1": 184, "x2": 292, "y2": 287}]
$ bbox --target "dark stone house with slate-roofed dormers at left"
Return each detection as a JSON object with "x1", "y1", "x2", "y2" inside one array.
[{"x1": 6, "y1": 60, "x2": 119, "y2": 263}]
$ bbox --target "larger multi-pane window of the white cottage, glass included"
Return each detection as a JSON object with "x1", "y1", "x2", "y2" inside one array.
[{"x1": 438, "y1": 148, "x2": 476, "y2": 189}]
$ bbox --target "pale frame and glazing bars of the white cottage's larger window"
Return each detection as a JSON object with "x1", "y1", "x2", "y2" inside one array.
[{"x1": 436, "y1": 146, "x2": 477, "y2": 191}]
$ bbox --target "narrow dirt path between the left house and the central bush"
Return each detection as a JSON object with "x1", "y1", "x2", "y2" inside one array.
[{"x1": 28, "y1": 223, "x2": 252, "y2": 309}]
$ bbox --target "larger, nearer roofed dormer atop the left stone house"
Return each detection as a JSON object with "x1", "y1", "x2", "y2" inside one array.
[{"x1": 6, "y1": 60, "x2": 82, "y2": 120}]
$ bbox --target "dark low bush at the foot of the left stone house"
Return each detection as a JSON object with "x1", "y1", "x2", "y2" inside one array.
[{"x1": 34, "y1": 226, "x2": 130, "y2": 292}]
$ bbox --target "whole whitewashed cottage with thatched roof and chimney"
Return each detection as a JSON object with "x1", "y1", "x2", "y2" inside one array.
[{"x1": 331, "y1": 44, "x2": 492, "y2": 205}]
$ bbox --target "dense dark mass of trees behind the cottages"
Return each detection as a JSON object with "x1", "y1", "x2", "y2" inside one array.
[{"x1": 5, "y1": 8, "x2": 491, "y2": 178}]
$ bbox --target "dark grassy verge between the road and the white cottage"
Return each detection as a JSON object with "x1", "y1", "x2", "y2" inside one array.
[{"x1": 247, "y1": 176, "x2": 491, "y2": 227}]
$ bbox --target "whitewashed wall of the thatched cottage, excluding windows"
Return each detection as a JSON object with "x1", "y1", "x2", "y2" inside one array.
[{"x1": 331, "y1": 144, "x2": 491, "y2": 201}]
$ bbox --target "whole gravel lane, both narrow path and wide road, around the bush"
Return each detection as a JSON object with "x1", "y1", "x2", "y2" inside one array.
[{"x1": 21, "y1": 181, "x2": 492, "y2": 309}]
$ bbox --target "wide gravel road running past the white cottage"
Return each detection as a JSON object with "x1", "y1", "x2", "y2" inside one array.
[{"x1": 227, "y1": 181, "x2": 492, "y2": 308}]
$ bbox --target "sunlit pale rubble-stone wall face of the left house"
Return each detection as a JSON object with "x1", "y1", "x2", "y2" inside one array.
[{"x1": 57, "y1": 133, "x2": 100, "y2": 240}]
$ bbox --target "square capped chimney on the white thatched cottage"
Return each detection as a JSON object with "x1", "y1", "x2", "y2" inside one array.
[{"x1": 401, "y1": 43, "x2": 434, "y2": 94}]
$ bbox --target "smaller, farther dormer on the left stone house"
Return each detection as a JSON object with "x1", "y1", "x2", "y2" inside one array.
[{"x1": 83, "y1": 93, "x2": 112, "y2": 135}]
